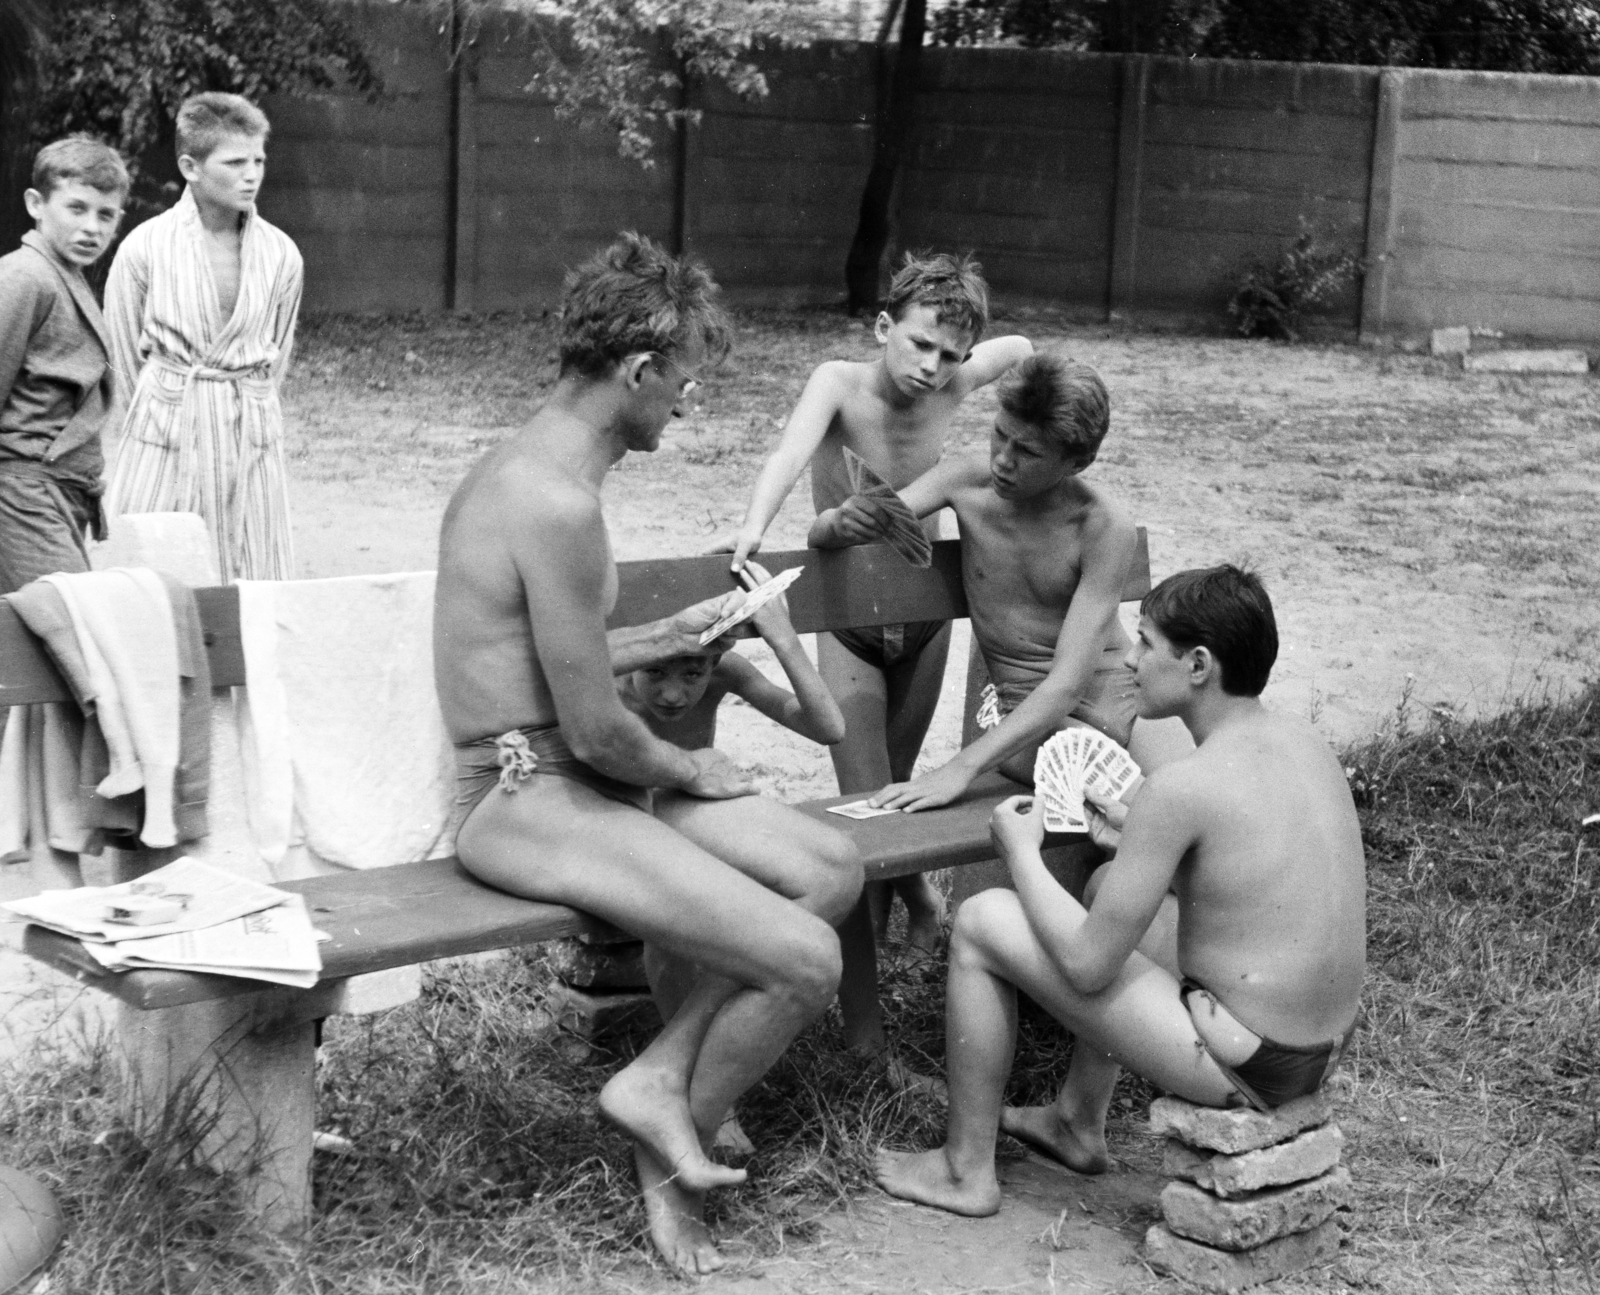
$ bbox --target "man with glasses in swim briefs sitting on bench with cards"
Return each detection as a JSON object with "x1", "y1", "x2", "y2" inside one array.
[{"x1": 434, "y1": 234, "x2": 861, "y2": 1274}]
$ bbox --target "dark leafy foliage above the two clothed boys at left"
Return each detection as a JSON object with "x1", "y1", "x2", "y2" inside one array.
[{"x1": 34, "y1": 0, "x2": 381, "y2": 198}]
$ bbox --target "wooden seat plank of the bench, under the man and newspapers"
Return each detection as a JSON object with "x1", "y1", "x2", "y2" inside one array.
[{"x1": 24, "y1": 773, "x2": 1082, "y2": 1008}]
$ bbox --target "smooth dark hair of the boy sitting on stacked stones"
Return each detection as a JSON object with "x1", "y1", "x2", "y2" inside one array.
[{"x1": 1139, "y1": 563, "x2": 1278, "y2": 696}]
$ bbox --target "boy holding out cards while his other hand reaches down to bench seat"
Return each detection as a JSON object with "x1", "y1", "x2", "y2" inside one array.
[{"x1": 808, "y1": 344, "x2": 1149, "y2": 810}]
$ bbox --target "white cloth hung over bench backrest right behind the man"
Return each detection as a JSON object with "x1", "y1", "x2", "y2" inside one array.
[{"x1": 238, "y1": 571, "x2": 456, "y2": 879}]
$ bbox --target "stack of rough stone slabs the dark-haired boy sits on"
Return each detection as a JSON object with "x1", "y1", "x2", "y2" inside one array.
[{"x1": 1144, "y1": 1093, "x2": 1350, "y2": 1290}]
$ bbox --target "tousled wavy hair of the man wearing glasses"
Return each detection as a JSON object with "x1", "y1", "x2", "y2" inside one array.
[{"x1": 562, "y1": 232, "x2": 731, "y2": 378}]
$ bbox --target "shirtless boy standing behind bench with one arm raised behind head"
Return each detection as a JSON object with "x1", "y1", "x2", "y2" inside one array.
[{"x1": 720, "y1": 253, "x2": 1034, "y2": 1055}]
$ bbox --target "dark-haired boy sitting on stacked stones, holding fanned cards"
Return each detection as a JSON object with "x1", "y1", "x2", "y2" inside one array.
[{"x1": 878, "y1": 567, "x2": 1366, "y2": 1215}]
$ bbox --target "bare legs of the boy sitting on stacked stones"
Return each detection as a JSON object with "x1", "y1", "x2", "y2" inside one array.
[{"x1": 878, "y1": 890, "x2": 1232, "y2": 1213}]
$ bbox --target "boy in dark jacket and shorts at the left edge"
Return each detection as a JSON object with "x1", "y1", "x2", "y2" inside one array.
[{"x1": 0, "y1": 134, "x2": 128, "y2": 594}]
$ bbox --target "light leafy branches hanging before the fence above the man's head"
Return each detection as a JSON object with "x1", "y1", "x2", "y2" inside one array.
[{"x1": 467, "y1": 0, "x2": 821, "y2": 166}]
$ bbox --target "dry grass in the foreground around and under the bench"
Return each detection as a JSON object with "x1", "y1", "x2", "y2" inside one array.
[{"x1": 0, "y1": 688, "x2": 1600, "y2": 1295}]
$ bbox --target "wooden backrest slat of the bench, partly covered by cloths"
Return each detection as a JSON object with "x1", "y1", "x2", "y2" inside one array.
[{"x1": 0, "y1": 527, "x2": 1150, "y2": 708}]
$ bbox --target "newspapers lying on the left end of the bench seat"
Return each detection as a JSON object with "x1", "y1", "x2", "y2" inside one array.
[{"x1": 0, "y1": 856, "x2": 322, "y2": 988}]
